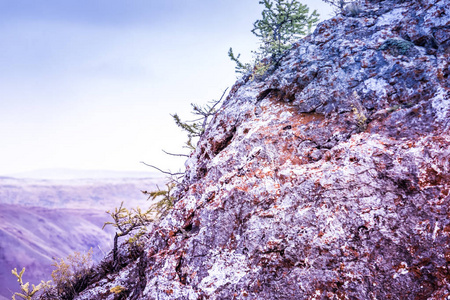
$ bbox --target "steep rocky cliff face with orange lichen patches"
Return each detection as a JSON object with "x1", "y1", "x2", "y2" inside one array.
[{"x1": 73, "y1": 0, "x2": 450, "y2": 299}]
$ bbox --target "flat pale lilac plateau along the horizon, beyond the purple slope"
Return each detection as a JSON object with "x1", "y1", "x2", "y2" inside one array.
[{"x1": 0, "y1": 176, "x2": 165, "y2": 209}]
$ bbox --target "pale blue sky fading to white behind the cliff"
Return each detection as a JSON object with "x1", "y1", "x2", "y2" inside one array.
[{"x1": 0, "y1": 0, "x2": 332, "y2": 176}]
